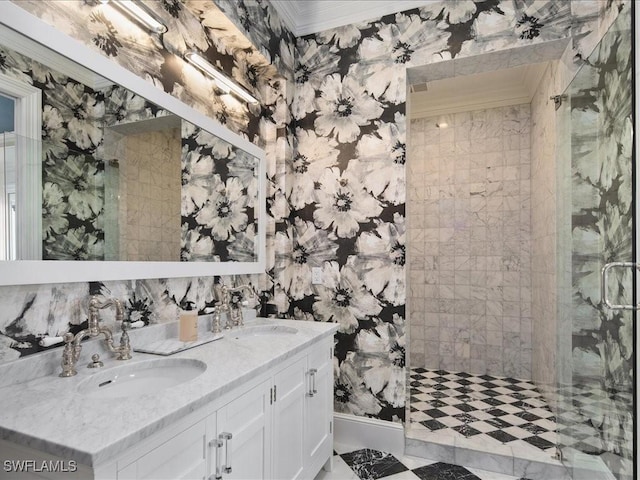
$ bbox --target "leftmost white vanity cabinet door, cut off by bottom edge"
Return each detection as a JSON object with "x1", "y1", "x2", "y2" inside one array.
[{"x1": 118, "y1": 422, "x2": 207, "y2": 480}]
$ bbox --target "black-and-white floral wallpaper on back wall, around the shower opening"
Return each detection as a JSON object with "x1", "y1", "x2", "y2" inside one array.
[{"x1": 288, "y1": 0, "x2": 584, "y2": 421}]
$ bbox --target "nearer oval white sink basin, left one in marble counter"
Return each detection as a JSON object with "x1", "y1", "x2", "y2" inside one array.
[{"x1": 78, "y1": 358, "x2": 207, "y2": 398}]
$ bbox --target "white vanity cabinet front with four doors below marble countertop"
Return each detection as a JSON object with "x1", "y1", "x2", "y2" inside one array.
[{"x1": 111, "y1": 338, "x2": 333, "y2": 480}]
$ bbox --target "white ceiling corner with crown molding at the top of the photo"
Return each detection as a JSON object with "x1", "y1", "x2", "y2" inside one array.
[{"x1": 271, "y1": 0, "x2": 436, "y2": 37}]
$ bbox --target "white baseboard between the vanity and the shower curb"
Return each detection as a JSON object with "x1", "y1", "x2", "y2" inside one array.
[{"x1": 333, "y1": 413, "x2": 404, "y2": 456}]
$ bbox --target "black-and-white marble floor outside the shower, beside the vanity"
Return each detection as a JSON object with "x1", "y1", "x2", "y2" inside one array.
[{"x1": 315, "y1": 445, "x2": 526, "y2": 480}]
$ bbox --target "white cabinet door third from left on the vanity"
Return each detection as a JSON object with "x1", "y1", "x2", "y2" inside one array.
[{"x1": 272, "y1": 358, "x2": 307, "y2": 480}]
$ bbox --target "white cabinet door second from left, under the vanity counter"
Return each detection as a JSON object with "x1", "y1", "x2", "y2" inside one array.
[{"x1": 216, "y1": 381, "x2": 271, "y2": 480}]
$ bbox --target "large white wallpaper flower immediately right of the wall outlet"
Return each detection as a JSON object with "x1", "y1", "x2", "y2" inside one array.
[{"x1": 313, "y1": 262, "x2": 382, "y2": 333}]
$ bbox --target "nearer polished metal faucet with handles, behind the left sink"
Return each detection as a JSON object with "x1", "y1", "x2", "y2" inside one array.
[{"x1": 60, "y1": 295, "x2": 131, "y2": 377}]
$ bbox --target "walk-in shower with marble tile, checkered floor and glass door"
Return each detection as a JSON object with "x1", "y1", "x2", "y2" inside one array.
[{"x1": 406, "y1": 9, "x2": 635, "y2": 479}]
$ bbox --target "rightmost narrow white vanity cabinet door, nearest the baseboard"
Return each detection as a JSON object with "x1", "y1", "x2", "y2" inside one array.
[{"x1": 304, "y1": 340, "x2": 333, "y2": 476}]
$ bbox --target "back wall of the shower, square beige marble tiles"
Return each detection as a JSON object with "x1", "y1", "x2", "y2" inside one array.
[{"x1": 407, "y1": 105, "x2": 531, "y2": 379}]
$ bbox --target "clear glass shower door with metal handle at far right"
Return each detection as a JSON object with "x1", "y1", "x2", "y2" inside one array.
[{"x1": 557, "y1": 8, "x2": 638, "y2": 480}]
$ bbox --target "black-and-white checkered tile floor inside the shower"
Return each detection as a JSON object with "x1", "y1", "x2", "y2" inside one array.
[{"x1": 410, "y1": 368, "x2": 556, "y2": 455}]
